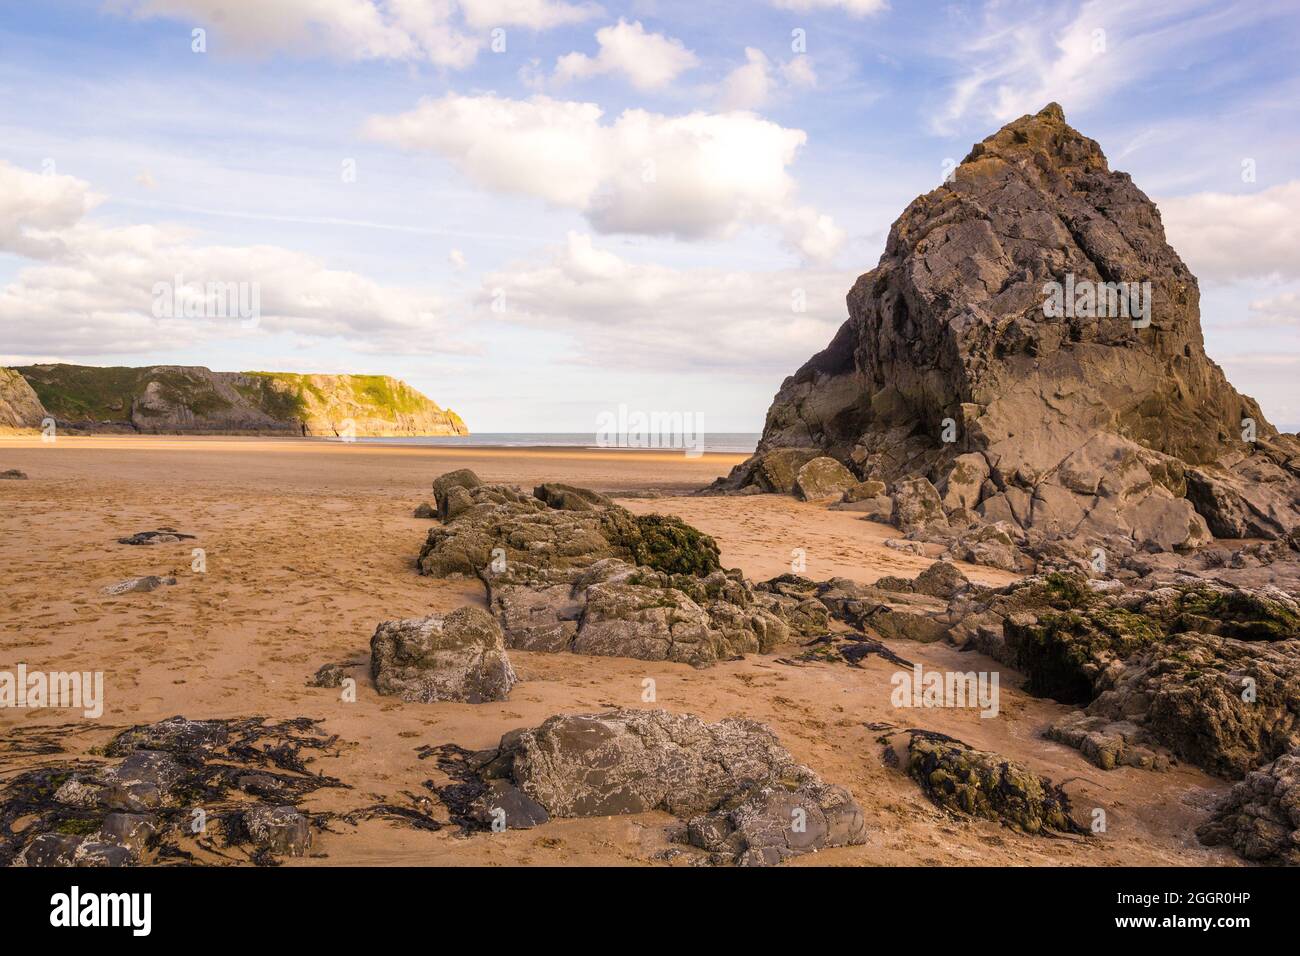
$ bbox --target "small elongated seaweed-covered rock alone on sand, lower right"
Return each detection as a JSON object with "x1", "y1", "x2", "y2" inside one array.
[{"x1": 907, "y1": 734, "x2": 1084, "y2": 834}]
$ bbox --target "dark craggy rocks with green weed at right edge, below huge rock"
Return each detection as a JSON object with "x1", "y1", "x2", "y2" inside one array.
[{"x1": 946, "y1": 572, "x2": 1300, "y2": 778}]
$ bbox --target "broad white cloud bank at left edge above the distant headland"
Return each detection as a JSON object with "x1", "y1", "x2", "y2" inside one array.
[{"x1": 0, "y1": 161, "x2": 455, "y2": 355}]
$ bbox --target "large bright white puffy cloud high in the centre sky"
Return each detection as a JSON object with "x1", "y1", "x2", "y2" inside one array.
[{"x1": 365, "y1": 94, "x2": 844, "y2": 260}]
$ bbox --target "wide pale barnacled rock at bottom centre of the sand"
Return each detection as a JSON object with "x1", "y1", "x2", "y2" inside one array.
[{"x1": 431, "y1": 710, "x2": 866, "y2": 865}]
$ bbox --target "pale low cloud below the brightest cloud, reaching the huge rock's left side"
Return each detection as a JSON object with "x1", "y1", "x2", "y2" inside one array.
[{"x1": 480, "y1": 233, "x2": 854, "y2": 372}]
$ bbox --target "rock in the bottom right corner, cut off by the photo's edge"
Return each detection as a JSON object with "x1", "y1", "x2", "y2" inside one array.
[{"x1": 1196, "y1": 750, "x2": 1300, "y2": 866}]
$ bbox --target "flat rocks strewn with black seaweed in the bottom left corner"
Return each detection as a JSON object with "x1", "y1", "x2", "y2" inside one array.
[{"x1": 0, "y1": 717, "x2": 343, "y2": 866}]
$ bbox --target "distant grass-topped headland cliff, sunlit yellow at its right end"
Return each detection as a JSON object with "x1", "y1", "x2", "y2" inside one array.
[{"x1": 11, "y1": 364, "x2": 469, "y2": 437}]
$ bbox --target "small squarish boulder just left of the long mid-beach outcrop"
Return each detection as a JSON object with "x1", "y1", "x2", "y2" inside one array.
[{"x1": 371, "y1": 607, "x2": 516, "y2": 704}]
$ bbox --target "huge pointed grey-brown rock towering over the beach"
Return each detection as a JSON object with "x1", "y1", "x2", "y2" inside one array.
[{"x1": 716, "y1": 104, "x2": 1300, "y2": 564}]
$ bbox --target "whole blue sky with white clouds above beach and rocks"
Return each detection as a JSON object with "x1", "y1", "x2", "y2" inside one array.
[{"x1": 0, "y1": 0, "x2": 1300, "y2": 432}]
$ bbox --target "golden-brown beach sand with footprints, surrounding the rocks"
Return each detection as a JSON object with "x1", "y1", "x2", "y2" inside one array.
[{"x1": 0, "y1": 437, "x2": 1235, "y2": 866}]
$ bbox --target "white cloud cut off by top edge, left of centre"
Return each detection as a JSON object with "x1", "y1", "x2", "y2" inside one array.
[{"x1": 108, "y1": 0, "x2": 601, "y2": 69}]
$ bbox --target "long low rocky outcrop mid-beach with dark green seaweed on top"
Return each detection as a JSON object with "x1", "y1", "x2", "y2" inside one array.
[{"x1": 419, "y1": 471, "x2": 826, "y2": 666}]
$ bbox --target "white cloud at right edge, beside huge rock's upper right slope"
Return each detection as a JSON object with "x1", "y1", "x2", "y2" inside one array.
[{"x1": 1158, "y1": 179, "x2": 1300, "y2": 281}]
